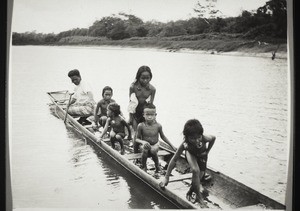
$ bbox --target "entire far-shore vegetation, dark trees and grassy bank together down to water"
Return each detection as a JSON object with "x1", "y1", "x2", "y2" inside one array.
[{"x1": 12, "y1": 0, "x2": 287, "y2": 51}]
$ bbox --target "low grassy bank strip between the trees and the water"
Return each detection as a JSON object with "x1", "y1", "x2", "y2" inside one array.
[{"x1": 57, "y1": 34, "x2": 287, "y2": 53}]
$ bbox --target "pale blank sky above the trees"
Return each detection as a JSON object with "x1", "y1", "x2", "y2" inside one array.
[{"x1": 12, "y1": 0, "x2": 266, "y2": 33}]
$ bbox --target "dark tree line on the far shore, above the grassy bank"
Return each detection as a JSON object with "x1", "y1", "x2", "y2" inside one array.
[{"x1": 12, "y1": 0, "x2": 287, "y2": 45}]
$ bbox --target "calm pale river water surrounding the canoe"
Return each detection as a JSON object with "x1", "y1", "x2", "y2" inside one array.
[{"x1": 10, "y1": 46, "x2": 289, "y2": 209}]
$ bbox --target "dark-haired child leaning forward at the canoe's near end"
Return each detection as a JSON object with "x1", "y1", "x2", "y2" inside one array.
[{"x1": 160, "y1": 119, "x2": 216, "y2": 206}]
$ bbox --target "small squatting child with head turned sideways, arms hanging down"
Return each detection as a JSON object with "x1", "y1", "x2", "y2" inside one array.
[{"x1": 100, "y1": 102, "x2": 131, "y2": 155}]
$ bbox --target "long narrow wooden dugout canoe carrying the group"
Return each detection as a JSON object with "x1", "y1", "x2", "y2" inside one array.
[{"x1": 47, "y1": 91, "x2": 286, "y2": 210}]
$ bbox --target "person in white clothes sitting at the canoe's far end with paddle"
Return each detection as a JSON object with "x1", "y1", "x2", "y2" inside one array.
[{"x1": 68, "y1": 69, "x2": 95, "y2": 125}]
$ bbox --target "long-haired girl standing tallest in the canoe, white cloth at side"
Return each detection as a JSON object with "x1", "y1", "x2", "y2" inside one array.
[{"x1": 128, "y1": 66, "x2": 156, "y2": 153}]
